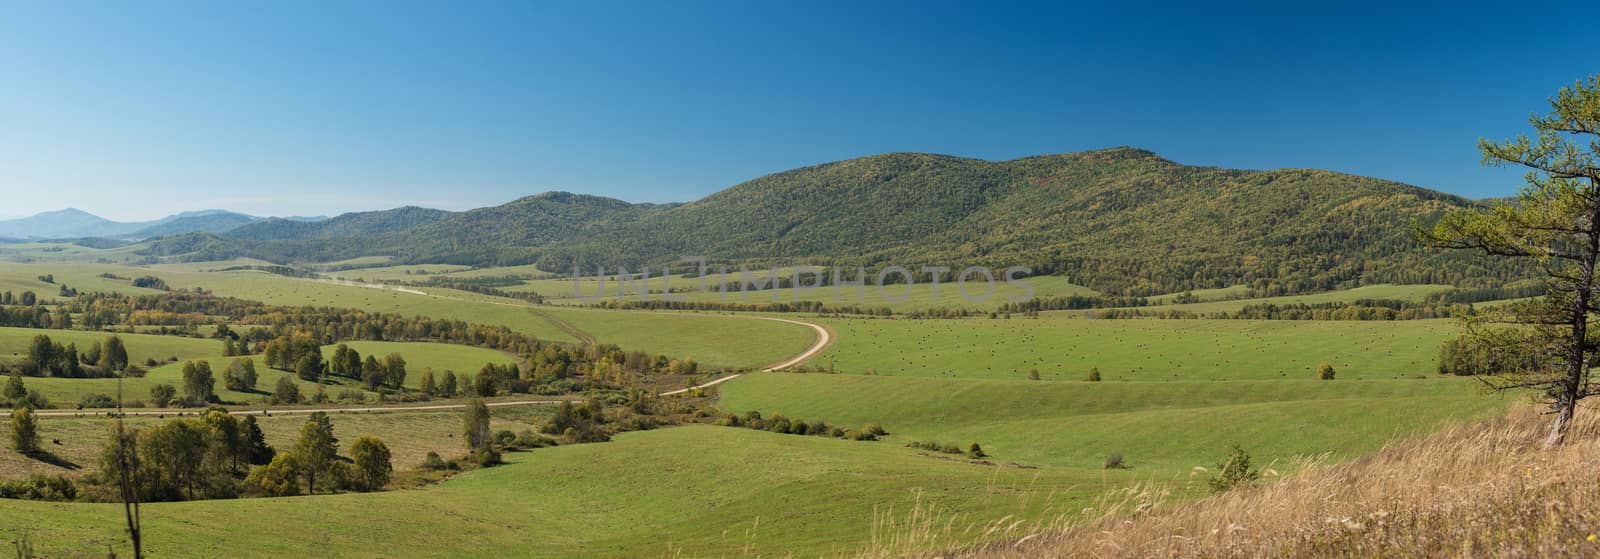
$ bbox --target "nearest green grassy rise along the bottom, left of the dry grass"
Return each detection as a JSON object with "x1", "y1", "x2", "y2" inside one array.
[{"x1": 0, "y1": 418, "x2": 1113, "y2": 557}]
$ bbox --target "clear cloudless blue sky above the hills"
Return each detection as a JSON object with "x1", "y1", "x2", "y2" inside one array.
[{"x1": 0, "y1": 0, "x2": 1600, "y2": 219}]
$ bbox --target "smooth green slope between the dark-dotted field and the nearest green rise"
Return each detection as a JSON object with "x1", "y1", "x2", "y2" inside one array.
[{"x1": 718, "y1": 373, "x2": 1512, "y2": 474}]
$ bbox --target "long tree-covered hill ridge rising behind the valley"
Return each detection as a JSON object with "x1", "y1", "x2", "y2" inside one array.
[{"x1": 140, "y1": 147, "x2": 1528, "y2": 295}]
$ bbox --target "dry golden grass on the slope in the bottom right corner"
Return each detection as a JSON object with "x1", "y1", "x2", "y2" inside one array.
[{"x1": 862, "y1": 400, "x2": 1600, "y2": 559}]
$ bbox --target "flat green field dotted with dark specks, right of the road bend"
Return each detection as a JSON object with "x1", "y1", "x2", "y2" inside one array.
[{"x1": 810, "y1": 317, "x2": 1459, "y2": 381}]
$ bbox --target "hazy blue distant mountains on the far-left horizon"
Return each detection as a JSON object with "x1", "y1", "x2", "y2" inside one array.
[{"x1": 0, "y1": 208, "x2": 326, "y2": 240}]
